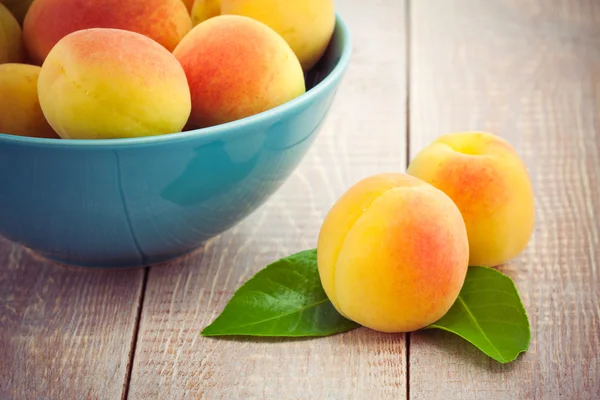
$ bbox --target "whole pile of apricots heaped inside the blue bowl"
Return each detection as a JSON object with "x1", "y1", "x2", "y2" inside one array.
[{"x1": 0, "y1": 0, "x2": 335, "y2": 139}]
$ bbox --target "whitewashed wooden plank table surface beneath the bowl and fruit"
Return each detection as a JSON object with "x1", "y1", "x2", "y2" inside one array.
[{"x1": 0, "y1": 0, "x2": 600, "y2": 400}]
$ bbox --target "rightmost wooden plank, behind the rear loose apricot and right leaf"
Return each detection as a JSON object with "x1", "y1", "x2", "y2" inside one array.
[{"x1": 409, "y1": 0, "x2": 600, "y2": 399}]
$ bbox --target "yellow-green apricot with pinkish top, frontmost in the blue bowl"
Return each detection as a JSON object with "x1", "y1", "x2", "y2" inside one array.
[{"x1": 36, "y1": 27, "x2": 191, "y2": 139}]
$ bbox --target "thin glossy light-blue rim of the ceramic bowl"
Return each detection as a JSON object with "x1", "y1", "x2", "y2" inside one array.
[{"x1": 0, "y1": 12, "x2": 352, "y2": 148}]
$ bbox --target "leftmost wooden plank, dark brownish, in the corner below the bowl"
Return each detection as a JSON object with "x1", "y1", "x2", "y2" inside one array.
[{"x1": 0, "y1": 238, "x2": 144, "y2": 400}]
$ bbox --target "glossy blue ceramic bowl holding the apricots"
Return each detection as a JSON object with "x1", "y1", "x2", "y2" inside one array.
[{"x1": 0, "y1": 16, "x2": 351, "y2": 267}]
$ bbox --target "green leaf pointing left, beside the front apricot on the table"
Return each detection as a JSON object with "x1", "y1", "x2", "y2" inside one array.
[{"x1": 202, "y1": 249, "x2": 359, "y2": 337}]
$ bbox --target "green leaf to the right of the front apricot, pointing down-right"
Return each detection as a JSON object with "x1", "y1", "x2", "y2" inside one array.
[{"x1": 426, "y1": 267, "x2": 531, "y2": 364}]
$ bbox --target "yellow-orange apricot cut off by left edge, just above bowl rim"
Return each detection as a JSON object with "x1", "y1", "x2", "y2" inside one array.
[{"x1": 0, "y1": 63, "x2": 59, "y2": 139}]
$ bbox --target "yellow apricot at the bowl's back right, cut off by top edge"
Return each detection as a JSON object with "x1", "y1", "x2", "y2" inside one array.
[{"x1": 221, "y1": 0, "x2": 335, "y2": 71}]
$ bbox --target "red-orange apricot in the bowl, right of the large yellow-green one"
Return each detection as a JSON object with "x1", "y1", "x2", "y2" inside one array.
[{"x1": 173, "y1": 15, "x2": 305, "y2": 128}]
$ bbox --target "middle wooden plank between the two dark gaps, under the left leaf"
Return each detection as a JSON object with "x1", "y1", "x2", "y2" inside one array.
[{"x1": 129, "y1": 0, "x2": 406, "y2": 400}]
